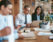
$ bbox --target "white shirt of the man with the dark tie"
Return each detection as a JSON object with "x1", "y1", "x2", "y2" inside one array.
[{"x1": 15, "y1": 13, "x2": 32, "y2": 26}]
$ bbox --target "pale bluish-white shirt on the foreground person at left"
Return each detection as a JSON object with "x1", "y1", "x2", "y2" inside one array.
[{"x1": 0, "y1": 14, "x2": 14, "y2": 42}]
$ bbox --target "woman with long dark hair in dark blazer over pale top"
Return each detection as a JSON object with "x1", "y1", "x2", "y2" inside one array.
[{"x1": 32, "y1": 6, "x2": 44, "y2": 21}]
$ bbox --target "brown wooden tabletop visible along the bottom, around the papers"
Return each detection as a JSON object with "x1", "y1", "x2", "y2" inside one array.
[{"x1": 4, "y1": 27, "x2": 53, "y2": 42}]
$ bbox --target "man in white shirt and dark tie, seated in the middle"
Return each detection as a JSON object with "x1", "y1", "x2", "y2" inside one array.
[{"x1": 15, "y1": 5, "x2": 32, "y2": 28}]
